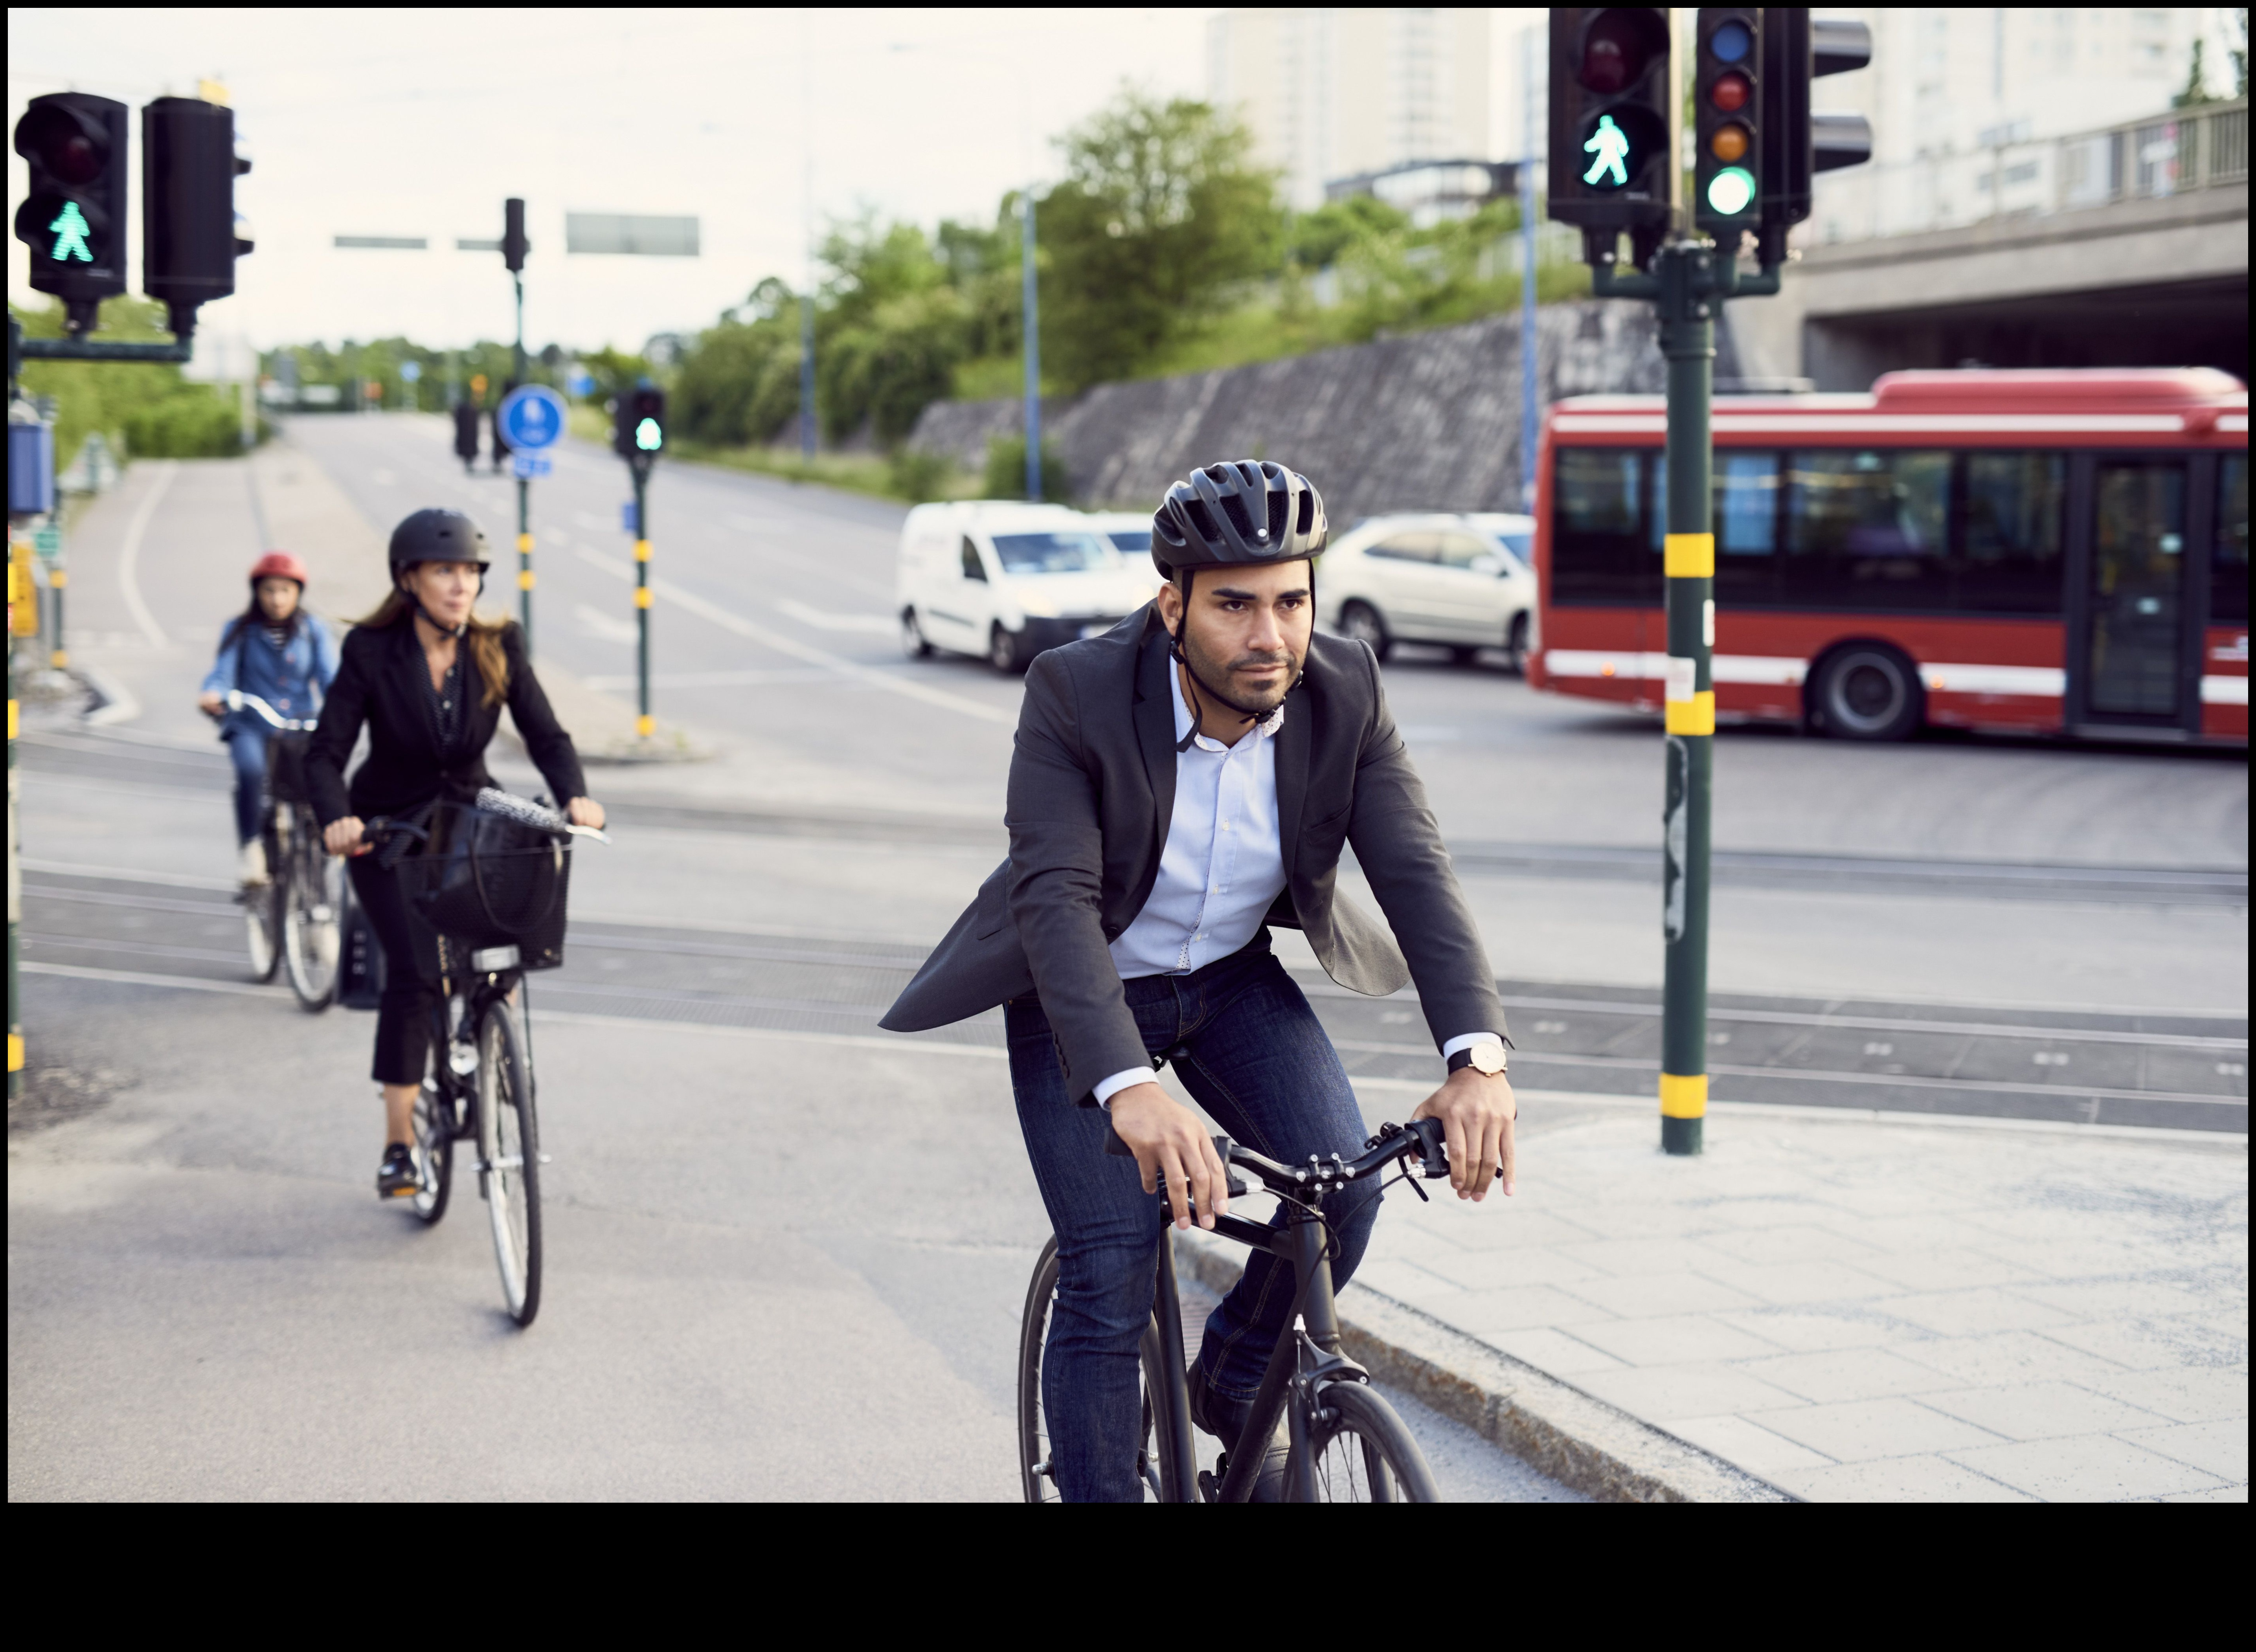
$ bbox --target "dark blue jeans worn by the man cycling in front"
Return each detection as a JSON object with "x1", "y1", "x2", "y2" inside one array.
[{"x1": 1004, "y1": 932, "x2": 1378, "y2": 1503}]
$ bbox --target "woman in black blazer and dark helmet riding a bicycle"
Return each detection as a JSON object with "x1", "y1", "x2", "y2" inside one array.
[{"x1": 305, "y1": 510, "x2": 603, "y2": 1199}]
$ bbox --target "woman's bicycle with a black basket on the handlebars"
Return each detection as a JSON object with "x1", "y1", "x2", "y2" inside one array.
[{"x1": 363, "y1": 787, "x2": 612, "y2": 1325}]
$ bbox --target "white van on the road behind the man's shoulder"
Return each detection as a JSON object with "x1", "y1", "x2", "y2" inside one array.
[{"x1": 893, "y1": 501, "x2": 1157, "y2": 672}]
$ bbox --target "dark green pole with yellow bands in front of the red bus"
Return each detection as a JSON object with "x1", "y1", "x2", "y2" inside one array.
[{"x1": 1593, "y1": 242, "x2": 1778, "y2": 1153}]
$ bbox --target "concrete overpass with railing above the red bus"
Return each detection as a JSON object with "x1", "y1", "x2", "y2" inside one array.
[{"x1": 1717, "y1": 104, "x2": 2249, "y2": 391}]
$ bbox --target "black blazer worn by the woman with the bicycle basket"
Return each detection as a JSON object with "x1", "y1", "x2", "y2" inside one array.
[{"x1": 305, "y1": 619, "x2": 586, "y2": 826}]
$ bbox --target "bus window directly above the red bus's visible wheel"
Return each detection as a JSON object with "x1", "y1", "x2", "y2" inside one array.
[{"x1": 1780, "y1": 449, "x2": 1951, "y2": 609}]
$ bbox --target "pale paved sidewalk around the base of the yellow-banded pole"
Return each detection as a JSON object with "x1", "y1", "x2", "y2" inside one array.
[{"x1": 1351, "y1": 1081, "x2": 2249, "y2": 1501}]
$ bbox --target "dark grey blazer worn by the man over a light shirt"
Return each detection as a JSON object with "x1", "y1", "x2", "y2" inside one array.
[{"x1": 880, "y1": 605, "x2": 1505, "y2": 1101}]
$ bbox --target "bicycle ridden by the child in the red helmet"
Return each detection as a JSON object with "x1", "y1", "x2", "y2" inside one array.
[{"x1": 214, "y1": 688, "x2": 350, "y2": 1015}]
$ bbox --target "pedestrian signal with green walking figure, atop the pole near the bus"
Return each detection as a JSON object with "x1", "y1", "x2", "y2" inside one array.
[{"x1": 1550, "y1": 7, "x2": 1672, "y2": 264}]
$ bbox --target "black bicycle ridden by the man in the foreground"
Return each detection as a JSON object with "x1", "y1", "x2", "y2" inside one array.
[{"x1": 1018, "y1": 1120, "x2": 1448, "y2": 1503}]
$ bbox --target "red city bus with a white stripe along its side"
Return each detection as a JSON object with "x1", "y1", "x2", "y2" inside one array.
[{"x1": 1530, "y1": 368, "x2": 2249, "y2": 743}]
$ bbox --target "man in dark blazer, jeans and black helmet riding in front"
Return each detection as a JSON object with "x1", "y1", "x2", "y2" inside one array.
[{"x1": 882, "y1": 463, "x2": 1518, "y2": 1501}]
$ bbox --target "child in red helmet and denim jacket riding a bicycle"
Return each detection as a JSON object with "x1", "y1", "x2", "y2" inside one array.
[{"x1": 196, "y1": 551, "x2": 336, "y2": 887}]
